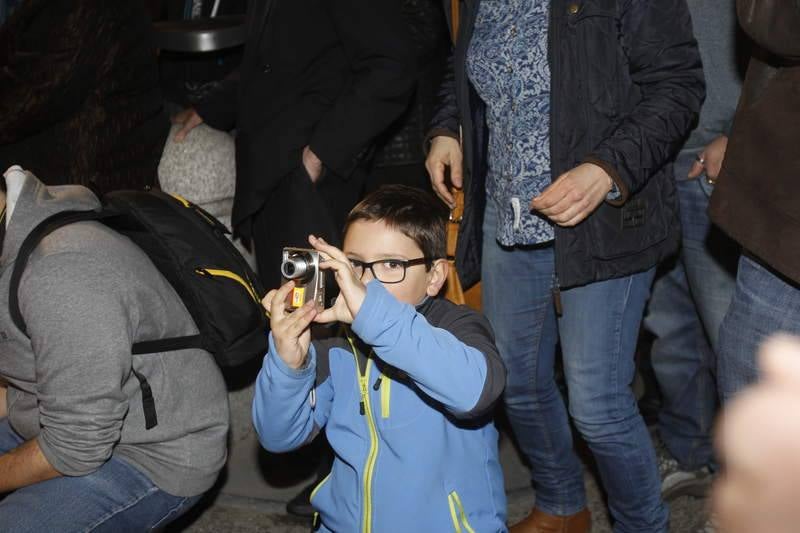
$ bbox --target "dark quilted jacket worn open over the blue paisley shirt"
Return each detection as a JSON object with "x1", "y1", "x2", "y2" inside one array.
[{"x1": 429, "y1": 0, "x2": 704, "y2": 287}]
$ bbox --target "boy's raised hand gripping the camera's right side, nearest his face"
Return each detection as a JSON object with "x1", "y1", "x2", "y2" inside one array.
[{"x1": 308, "y1": 235, "x2": 367, "y2": 324}]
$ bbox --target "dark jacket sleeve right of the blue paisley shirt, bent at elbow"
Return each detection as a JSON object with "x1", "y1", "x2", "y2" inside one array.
[{"x1": 584, "y1": 0, "x2": 705, "y2": 205}]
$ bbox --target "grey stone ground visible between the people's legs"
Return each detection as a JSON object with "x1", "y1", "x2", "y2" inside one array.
[{"x1": 169, "y1": 430, "x2": 707, "y2": 533}]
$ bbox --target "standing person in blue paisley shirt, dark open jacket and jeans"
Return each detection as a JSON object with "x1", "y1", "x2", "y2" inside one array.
[{"x1": 426, "y1": 0, "x2": 704, "y2": 533}]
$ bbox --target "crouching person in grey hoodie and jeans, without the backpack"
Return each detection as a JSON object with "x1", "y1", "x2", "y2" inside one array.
[{"x1": 0, "y1": 167, "x2": 228, "y2": 533}]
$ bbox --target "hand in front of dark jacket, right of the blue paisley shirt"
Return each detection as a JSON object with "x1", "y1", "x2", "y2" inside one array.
[{"x1": 531, "y1": 163, "x2": 613, "y2": 227}]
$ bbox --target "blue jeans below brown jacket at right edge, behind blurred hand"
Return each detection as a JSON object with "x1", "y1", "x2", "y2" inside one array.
[{"x1": 717, "y1": 255, "x2": 800, "y2": 402}]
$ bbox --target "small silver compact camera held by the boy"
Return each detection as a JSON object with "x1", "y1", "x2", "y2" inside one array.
[{"x1": 281, "y1": 248, "x2": 325, "y2": 311}]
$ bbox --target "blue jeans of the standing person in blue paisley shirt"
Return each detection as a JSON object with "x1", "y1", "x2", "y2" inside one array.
[{"x1": 481, "y1": 201, "x2": 669, "y2": 533}]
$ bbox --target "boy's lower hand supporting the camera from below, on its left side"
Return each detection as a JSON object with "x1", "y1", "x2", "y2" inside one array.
[{"x1": 261, "y1": 281, "x2": 317, "y2": 370}]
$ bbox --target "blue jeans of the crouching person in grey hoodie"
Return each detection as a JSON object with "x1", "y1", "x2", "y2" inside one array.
[{"x1": 0, "y1": 419, "x2": 200, "y2": 533}]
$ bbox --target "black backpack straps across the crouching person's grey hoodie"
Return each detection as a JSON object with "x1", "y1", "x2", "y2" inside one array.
[{"x1": 8, "y1": 210, "x2": 172, "y2": 429}]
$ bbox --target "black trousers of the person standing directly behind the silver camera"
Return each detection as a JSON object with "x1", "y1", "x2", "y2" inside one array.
[{"x1": 252, "y1": 164, "x2": 366, "y2": 289}]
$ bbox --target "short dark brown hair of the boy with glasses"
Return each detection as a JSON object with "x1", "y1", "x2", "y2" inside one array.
[{"x1": 342, "y1": 185, "x2": 449, "y2": 268}]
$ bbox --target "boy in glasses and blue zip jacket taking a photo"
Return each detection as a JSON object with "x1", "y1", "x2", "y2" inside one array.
[{"x1": 253, "y1": 185, "x2": 506, "y2": 533}]
